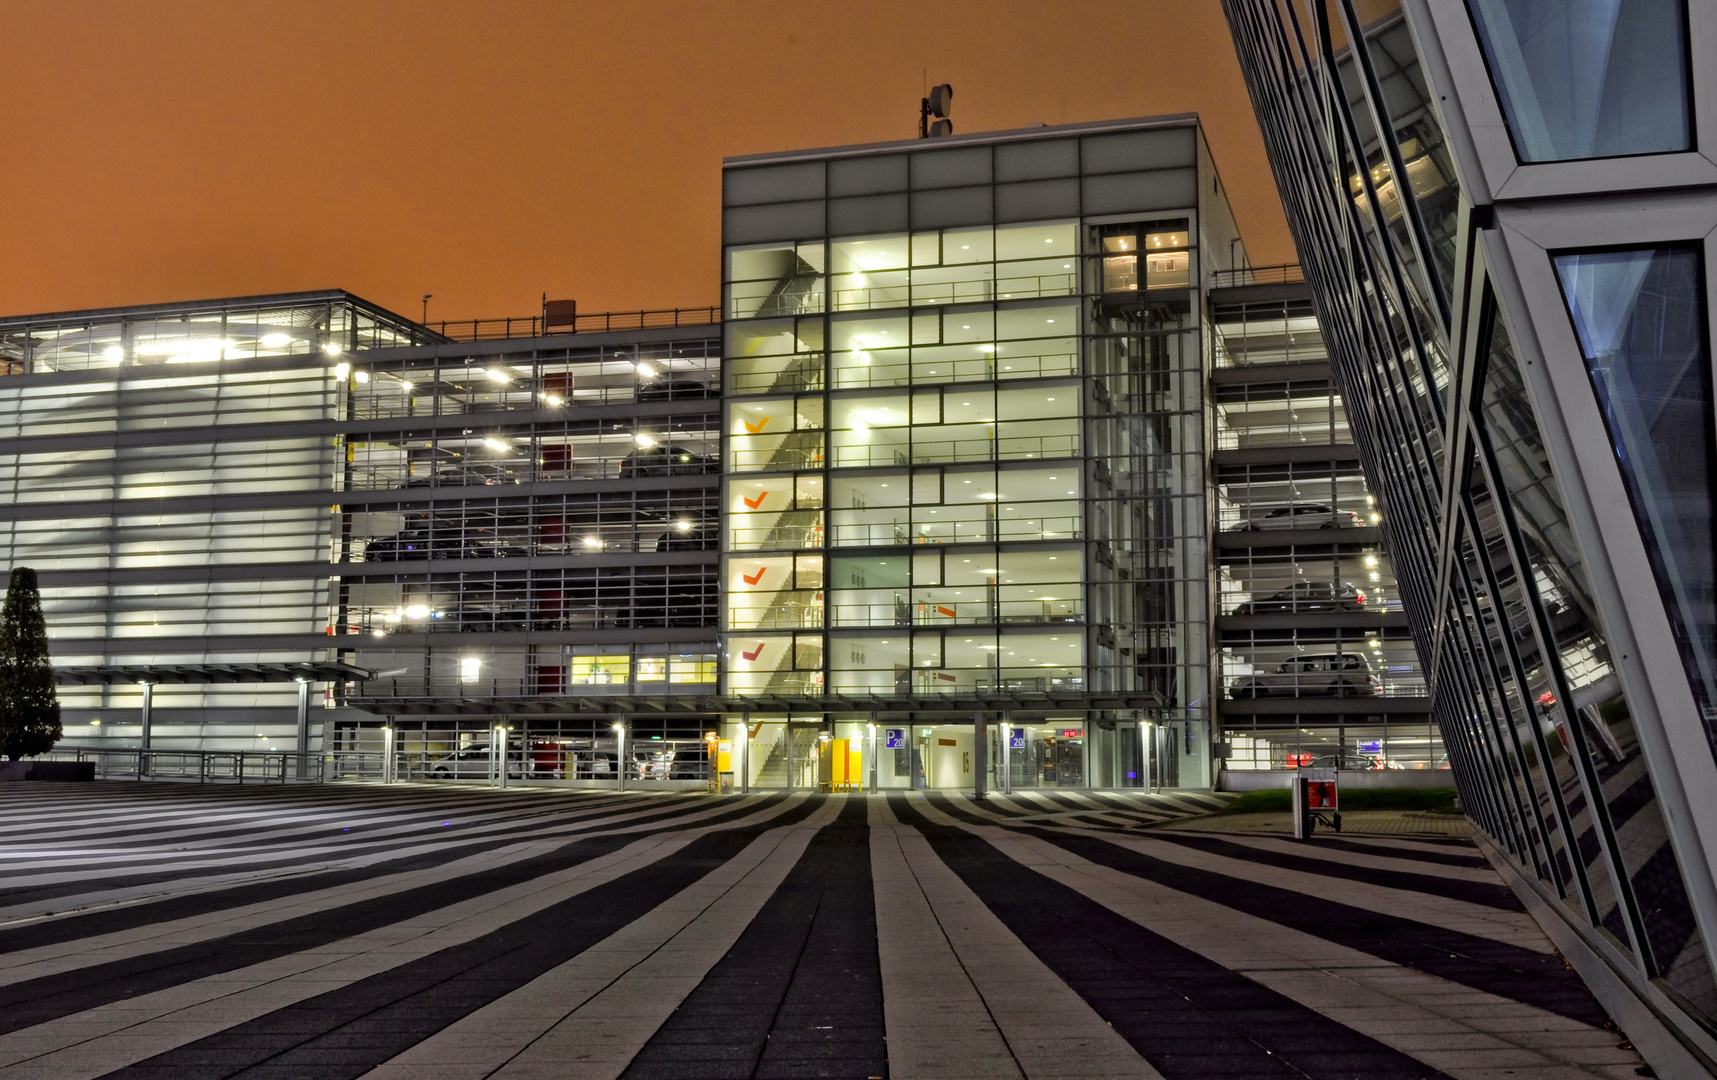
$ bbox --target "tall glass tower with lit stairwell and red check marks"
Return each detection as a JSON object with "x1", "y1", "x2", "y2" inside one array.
[{"x1": 721, "y1": 118, "x2": 1238, "y2": 788}]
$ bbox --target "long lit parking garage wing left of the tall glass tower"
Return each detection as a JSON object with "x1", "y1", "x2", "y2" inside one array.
[{"x1": 0, "y1": 292, "x2": 719, "y2": 765}]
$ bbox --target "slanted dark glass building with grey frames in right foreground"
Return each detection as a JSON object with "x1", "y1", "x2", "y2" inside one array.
[{"x1": 1224, "y1": 0, "x2": 1717, "y2": 1075}]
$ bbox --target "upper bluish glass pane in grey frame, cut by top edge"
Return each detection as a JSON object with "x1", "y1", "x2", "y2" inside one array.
[{"x1": 1470, "y1": 0, "x2": 1693, "y2": 161}]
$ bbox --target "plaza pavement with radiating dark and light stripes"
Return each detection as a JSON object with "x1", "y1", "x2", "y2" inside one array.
[{"x1": 0, "y1": 783, "x2": 1648, "y2": 1080}]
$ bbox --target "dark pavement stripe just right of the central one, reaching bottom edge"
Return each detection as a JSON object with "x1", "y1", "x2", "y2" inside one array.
[{"x1": 889, "y1": 797, "x2": 1444, "y2": 1080}]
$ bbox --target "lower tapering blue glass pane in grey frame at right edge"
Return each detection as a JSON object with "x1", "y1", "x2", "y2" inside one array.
[{"x1": 1556, "y1": 247, "x2": 1717, "y2": 758}]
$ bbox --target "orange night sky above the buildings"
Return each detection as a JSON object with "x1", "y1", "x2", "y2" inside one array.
[{"x1": 0, "y1": 0, "x2": 1293, "y2": 319}]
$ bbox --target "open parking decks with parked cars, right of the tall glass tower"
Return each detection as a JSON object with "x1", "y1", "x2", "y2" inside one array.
[{"x1": 1209, "y1": 266, "x2": 1449, "y2": 786}]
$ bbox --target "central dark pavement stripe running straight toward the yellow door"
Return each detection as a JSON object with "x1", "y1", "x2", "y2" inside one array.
[{"x1": 622, "y1": 798, "x2": 888, "y2": 1080}]
